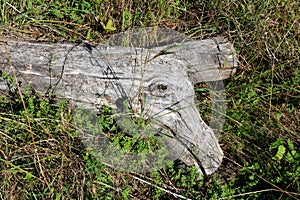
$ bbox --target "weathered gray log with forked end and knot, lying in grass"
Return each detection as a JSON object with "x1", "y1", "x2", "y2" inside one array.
[{"x1": 0, "y1": 35, "x2": 237, "y2": 175}]
